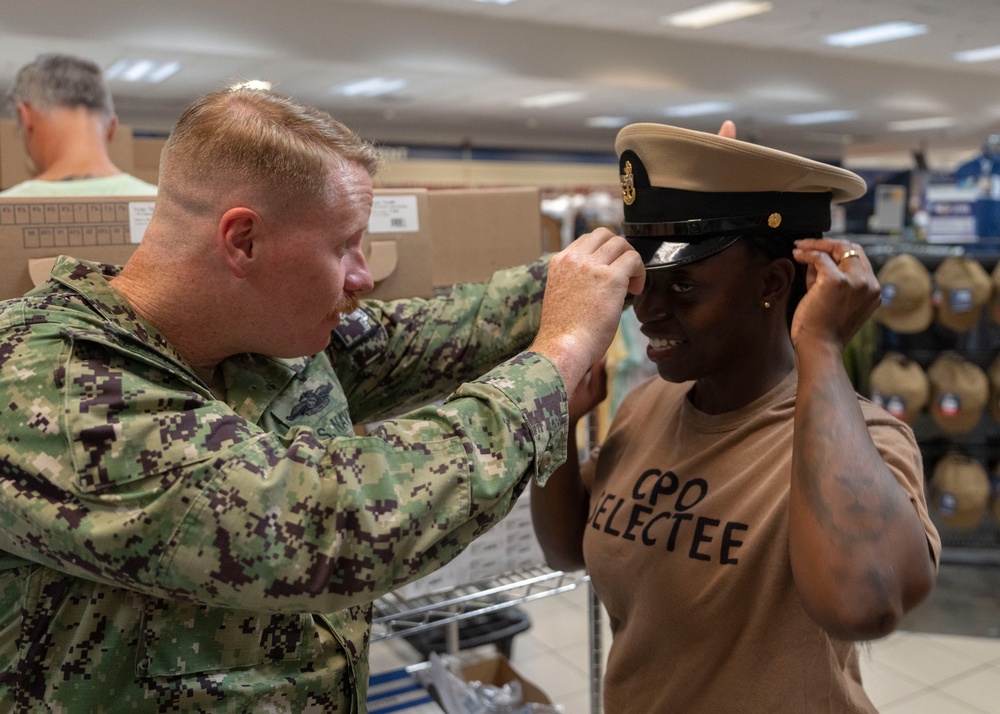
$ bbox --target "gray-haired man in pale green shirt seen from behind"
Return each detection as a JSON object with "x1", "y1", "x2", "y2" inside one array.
[{"x1": 0, "y1": 54, "x2": 156, "y2": 196}]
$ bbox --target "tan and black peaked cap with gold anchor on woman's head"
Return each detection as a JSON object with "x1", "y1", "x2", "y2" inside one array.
[{"x1": 615, "y1": 123, "x2": 867, "y2": 269}]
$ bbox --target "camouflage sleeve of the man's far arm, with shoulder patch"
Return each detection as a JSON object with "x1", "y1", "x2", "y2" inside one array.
[{"x1": 329, "y1": 257, "x2": 548, "y2": 423}]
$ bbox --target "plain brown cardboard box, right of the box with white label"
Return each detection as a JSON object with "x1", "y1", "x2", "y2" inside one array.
[{"x1": 428, "y1": 188, "x2": 542, "y2": 286}]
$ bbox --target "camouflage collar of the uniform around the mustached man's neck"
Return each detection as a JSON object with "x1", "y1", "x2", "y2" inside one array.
[{"x1": 49, "y1": 256, "x2": 309, "y2": 387}]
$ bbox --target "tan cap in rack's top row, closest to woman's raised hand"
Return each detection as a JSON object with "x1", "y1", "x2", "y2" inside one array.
[{"x1": 875, "y1": 253, "x2": 934, "y2": 334}]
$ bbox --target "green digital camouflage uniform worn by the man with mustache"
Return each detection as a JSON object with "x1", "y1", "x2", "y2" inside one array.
[{"x1": 0, "y1": 258, "x2": 566, "y2": 714}]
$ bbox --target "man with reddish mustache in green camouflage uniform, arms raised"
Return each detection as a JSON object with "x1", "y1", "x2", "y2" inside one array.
[{"x1": 0, "y1": 90, "x2": 643, "y2": 714}]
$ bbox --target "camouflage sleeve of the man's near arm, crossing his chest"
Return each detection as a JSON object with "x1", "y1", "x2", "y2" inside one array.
[{"x1": 0, "y1": 300, "x2": 566, "y2": 612}]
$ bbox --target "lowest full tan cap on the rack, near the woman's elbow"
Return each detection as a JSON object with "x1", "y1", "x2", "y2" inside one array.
[{"x1": 930, "y1": 451, "x2": 990, "y2": 530}]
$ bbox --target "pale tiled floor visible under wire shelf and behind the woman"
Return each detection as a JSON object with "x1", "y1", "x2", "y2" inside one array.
[{"x1": 371, "y1": 564, "x2": 1000, "y2": 714}]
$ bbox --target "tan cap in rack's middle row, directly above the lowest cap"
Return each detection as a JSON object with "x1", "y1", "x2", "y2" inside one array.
[{"x1": 927, "y1": 351, "x2": 990, "y2": 434}]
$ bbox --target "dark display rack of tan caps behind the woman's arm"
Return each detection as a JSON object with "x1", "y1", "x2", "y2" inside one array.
[{"x1": 866, "y1": 239, "x2": 1000, "y2": 563}]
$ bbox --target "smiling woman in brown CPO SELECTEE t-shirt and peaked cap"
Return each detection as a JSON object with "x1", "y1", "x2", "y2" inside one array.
[{"x1": 531, "y1": 124, "x2": 940, "y2": 714}]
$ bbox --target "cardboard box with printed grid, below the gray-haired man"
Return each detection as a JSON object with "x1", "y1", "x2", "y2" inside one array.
[{"x1": 0, "y1": 196, "x2": 153, "y2": 300}]
